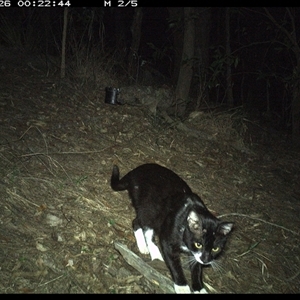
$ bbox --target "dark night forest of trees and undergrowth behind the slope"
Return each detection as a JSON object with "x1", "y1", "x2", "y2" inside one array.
[{"x1": 0, "y1": 7, "x2": 300, "y2": 143}]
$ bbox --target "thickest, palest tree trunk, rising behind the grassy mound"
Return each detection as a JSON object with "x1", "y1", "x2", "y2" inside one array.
[{"x1": 175, "y1": 7, "x2": 195, "y2": 117}]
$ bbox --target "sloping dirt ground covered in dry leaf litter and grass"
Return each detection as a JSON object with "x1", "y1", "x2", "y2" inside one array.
[{"x1": 0, "y1": 48, "x2": 300, "y2": 294}]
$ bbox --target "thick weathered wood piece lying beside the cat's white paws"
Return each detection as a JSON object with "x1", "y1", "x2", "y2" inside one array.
[{"x1": 114, "y1": 242, "x2": 175, "y2": 294}]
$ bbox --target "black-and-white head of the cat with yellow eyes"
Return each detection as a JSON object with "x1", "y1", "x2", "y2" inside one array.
[{"x1": 183, "y1": 210, "x2": 233, "y2": 265}]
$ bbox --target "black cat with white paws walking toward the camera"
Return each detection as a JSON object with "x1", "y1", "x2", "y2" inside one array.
[{"x1": 111, "y1": 164, "x2": 233, "y2": 293}]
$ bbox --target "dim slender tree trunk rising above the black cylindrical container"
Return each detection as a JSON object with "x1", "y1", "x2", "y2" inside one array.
[{"x1": 128, "y1": 7, "x2": 143, "y2": 82}]
